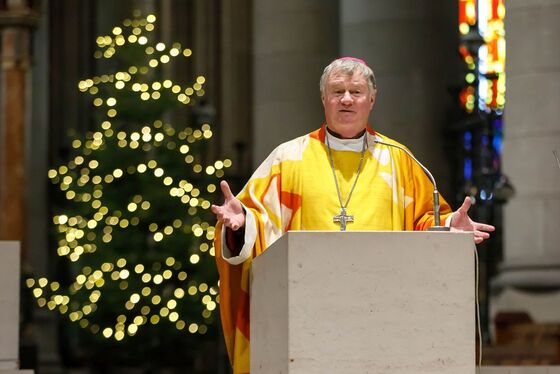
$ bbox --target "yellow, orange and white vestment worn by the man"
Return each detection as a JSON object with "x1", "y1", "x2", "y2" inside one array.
[{"x1": 214, "y1": 125, "x2": 451, "y2": 373}]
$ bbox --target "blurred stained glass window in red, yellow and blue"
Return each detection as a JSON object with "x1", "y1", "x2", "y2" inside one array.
[{"x1": 459, "y1": 0, "x2": 506, "y2": 191}]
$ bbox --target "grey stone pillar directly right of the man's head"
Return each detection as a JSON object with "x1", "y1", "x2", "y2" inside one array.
[{"x1": 340, "y1": 0, "x2": 462, "y2": 193}]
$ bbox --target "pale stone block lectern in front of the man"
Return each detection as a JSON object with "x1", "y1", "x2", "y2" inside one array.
[{"x1": 251, "y1": 231, "x2": 475, "y2": 374}]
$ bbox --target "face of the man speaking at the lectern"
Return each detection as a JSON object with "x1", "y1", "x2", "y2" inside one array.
[{"x1": 321, "y1": 72, "x2": 377, "y2": 138}]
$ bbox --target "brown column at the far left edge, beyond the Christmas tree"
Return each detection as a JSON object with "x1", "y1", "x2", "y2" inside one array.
[{"x1": 0, "y1": 0, "x2": 38, "y2": 247}]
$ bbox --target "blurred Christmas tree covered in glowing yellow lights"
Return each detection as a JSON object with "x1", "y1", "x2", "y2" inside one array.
[{"x1": 27, "y1": 13, "x2": 231, "y2": 361}]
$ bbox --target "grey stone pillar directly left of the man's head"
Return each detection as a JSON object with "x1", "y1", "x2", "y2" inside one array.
[{"x1": 252, "y1": 0, "x2": 338, "y2": 166}]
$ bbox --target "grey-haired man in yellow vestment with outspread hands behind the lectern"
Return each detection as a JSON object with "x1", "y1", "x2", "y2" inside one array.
[{"x1": 212, "y1": 57, "x2": 494, "y2": 373}]
